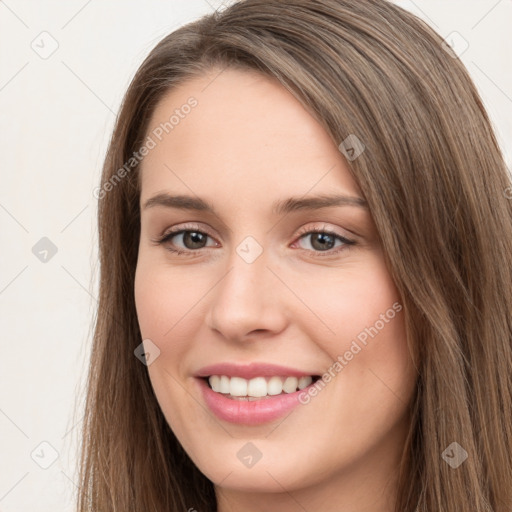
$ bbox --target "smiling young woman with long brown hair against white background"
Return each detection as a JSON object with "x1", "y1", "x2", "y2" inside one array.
[{"x1": 79, "y1": 0, "x2": 512, "y2": 512}]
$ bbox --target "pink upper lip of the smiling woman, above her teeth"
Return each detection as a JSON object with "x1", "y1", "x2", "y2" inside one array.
[{"x1": 196, "y1": 362, "x2": 318, "y2": 379}]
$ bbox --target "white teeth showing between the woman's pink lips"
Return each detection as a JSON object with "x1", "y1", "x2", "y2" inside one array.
[{"x1": 202, "y1": 375, "x2": 320, "y2": 401}]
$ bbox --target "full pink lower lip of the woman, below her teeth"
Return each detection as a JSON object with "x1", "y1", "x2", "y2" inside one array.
[{"x1": 197, "y1": 378, "x2": 313, "y2": 425}]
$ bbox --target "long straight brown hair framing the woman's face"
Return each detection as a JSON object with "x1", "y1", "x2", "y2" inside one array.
[{"x1": 78, "y1": 0, "x2": 512, "y2": 512}]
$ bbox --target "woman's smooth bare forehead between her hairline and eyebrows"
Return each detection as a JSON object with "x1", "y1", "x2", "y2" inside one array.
[{"x1": 137, "y1": 69, "x2": 360, "y2": 206}]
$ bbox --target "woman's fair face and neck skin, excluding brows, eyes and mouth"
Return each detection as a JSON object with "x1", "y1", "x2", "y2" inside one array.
[{"x1": 135, "y1": 70, "x2": 416, "y2": 512}]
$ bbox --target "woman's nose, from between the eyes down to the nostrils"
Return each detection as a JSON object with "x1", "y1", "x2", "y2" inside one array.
[{"x1": 206, "y1": 245, "x2": 288, "y2": 342}]
